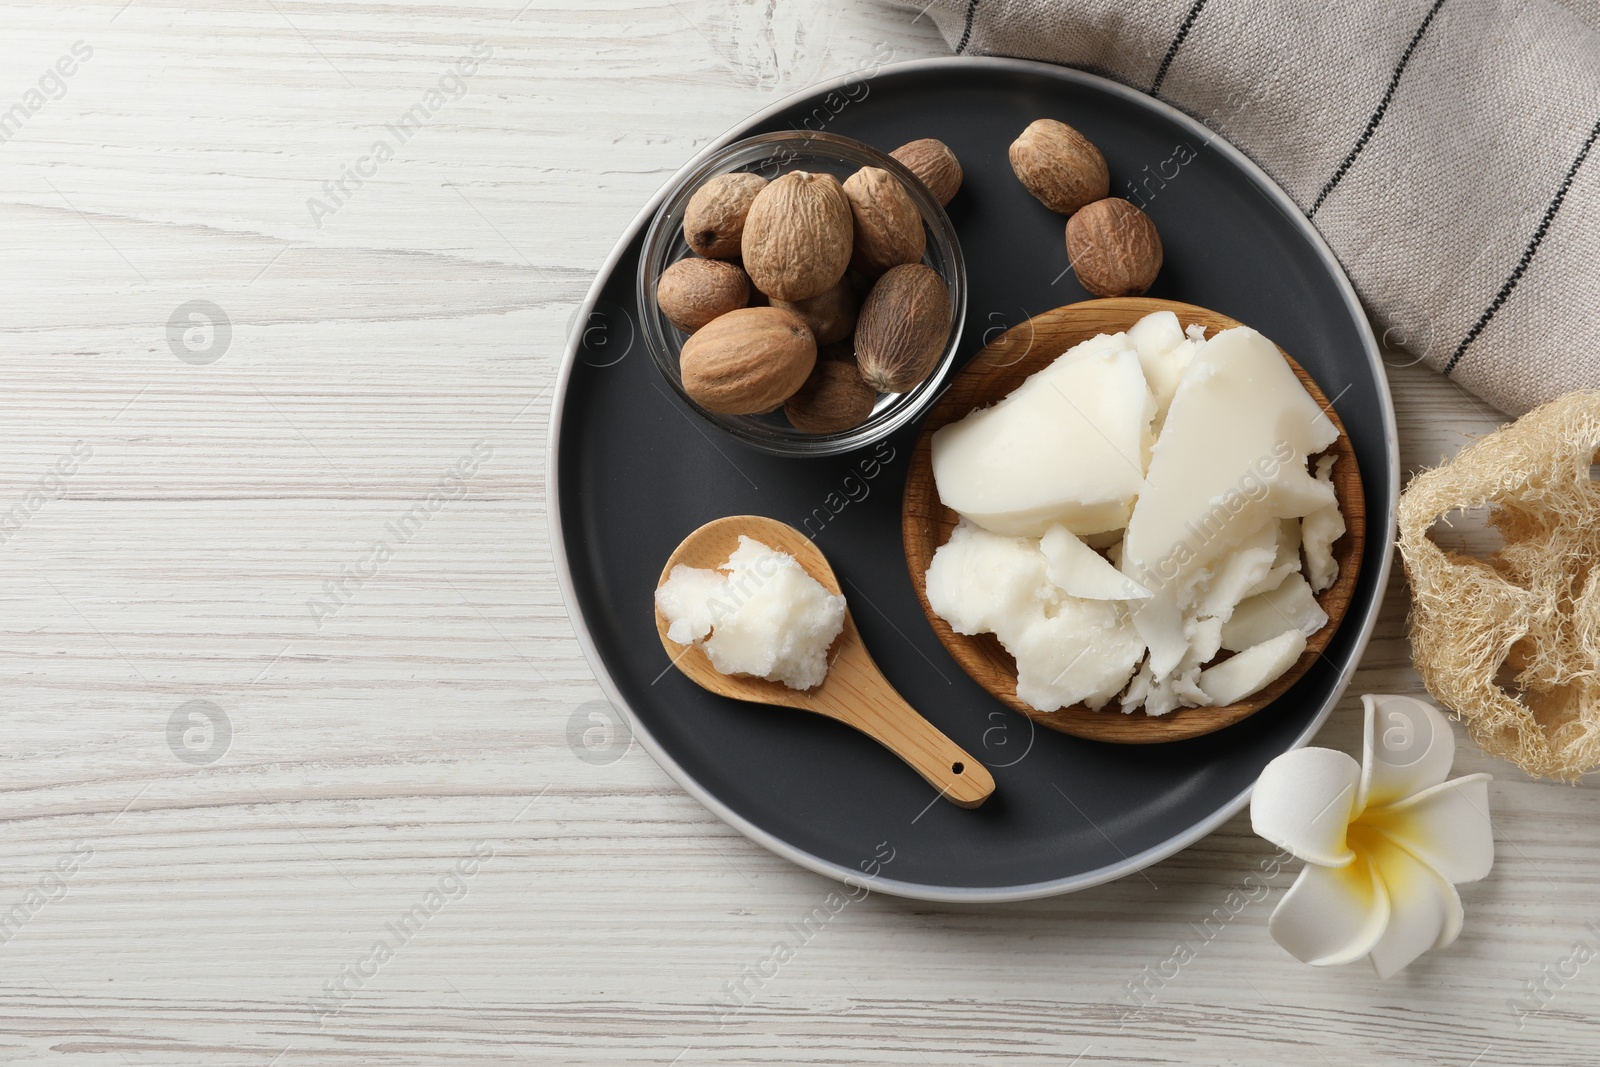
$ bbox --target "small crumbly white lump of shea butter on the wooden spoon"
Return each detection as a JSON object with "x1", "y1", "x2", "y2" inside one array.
[{"x1": 656, "y1": 534, "x2": 845, "y2": 689}]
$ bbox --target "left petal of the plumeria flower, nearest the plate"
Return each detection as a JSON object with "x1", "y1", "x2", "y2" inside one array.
[{"x1": 1250, "y1": 749, "x2": 1362, "y2": 867}]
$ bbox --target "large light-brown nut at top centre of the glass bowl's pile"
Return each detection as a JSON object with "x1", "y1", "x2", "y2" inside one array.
[{"x1": 741, "y1": 171, "x2": 854, "y2": 301}]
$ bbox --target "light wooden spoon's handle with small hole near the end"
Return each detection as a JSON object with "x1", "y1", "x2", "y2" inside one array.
[{"x1": 811, "y1": 621, "x2": 995, "y2": 808}]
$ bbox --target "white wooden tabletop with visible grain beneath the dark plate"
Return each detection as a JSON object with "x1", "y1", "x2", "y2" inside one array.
[{"x1": 0, "y1": 0, "x2": 1600, "y2": 1067}]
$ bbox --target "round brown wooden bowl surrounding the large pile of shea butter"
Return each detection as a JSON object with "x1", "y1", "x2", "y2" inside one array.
[{"x1": 901, "y1": 296, "x2": 1366, "y2": 744}]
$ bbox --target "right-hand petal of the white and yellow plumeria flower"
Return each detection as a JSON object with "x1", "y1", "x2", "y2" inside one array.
[{"x1": 1362, "y1": 774, "x2": 1494, "y2": 881}]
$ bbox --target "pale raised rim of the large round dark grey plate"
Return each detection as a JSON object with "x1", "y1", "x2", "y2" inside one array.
[{"x1": 544, "y1": 56, "x2": 1400, "y2": 904}]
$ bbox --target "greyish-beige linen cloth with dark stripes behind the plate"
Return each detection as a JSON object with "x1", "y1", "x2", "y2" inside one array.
[{"x1": 893, "y1": 0, "x2": 1600, "y2": 414}]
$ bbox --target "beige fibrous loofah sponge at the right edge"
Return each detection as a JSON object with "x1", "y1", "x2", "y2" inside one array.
[{"x1": 1400, "y1": 390, "x2": 1600, "y2": 781}]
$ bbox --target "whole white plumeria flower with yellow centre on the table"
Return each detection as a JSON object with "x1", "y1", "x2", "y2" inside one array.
[{"x1": 1250, "y1": 696, "x2": 1494, "y2": 977}]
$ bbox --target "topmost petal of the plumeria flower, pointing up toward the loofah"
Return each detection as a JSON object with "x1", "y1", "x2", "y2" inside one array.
[{"x1": 1355, "y1": 694, "x2": 1456, "y2": 813}]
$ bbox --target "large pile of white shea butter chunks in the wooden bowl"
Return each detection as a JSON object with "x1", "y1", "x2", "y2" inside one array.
[{"x1": 926, "y1": 312, "x2": 1344, "y2": 715}]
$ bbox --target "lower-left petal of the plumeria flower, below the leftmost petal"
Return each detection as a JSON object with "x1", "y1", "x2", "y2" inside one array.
[{"x1": 1267, "y1": 851, "x2": 1389, "y2": 966}]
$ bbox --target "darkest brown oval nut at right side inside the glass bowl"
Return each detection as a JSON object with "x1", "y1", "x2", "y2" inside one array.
[{"x1": 856, "y1": 262, "x2": 950, "y2": 392}]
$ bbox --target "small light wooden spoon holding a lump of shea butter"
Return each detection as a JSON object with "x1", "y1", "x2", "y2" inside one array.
[{"x1": 656, "y1": 515, "x2": 995, "y2": 808}]
